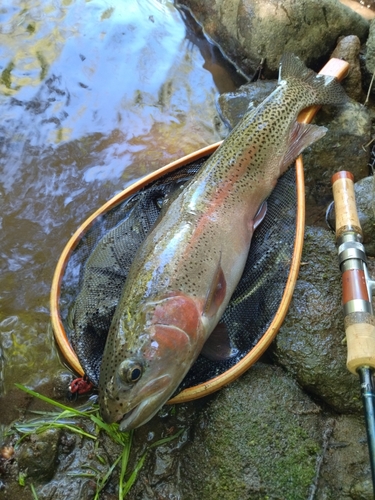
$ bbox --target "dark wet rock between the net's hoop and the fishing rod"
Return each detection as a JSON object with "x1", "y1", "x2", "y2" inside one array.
[{"x1": 271, "y1": 227, "x2": 362, "y2": 413}]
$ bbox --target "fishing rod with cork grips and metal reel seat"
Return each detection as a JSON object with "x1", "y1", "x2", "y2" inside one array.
[{"x1": 332, "y1": 171, "x2": 375, "y2": 497}]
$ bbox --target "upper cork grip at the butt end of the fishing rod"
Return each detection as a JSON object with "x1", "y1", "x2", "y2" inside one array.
[{"x1": 332, "y1": 170, "x2": 362, "y2": 239}]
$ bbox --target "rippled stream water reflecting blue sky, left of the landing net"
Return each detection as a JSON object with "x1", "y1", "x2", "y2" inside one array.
[{"x1": 0, "y1": 0, "x2": 244, "y2": 423}]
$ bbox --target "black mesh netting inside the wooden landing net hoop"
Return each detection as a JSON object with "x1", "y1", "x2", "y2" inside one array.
[{"x1": 60, "y1": 158, "x2": 297, "y2": 391}]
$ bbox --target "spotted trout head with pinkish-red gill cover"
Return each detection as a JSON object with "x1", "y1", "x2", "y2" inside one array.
[{"x1": 99, "y1": 295, "x2": 203, "y2": 431}]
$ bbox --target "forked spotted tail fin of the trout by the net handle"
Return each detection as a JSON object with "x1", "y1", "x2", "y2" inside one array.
[{"x1": 279, "y1": 53, "x2": 348, "y2": 105}]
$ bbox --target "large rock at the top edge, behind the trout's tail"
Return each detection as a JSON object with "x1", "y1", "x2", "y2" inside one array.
[{"x1": 180, "y1": 0, "x2": 369, "y2": 77}]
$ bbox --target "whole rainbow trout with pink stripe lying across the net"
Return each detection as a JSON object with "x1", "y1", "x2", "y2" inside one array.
[{"x1": 99, "y1": 54, "x2": 346, "y2": 431}]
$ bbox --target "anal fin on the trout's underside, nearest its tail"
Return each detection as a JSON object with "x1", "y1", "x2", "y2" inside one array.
[{"x1": 280, "y1": 122, "x2": 327, "y2": 173}]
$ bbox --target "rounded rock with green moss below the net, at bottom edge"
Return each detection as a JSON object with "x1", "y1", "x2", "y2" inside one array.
[{"x1": 180, "y1": 363, "x2": 322, "y2": 500}]
